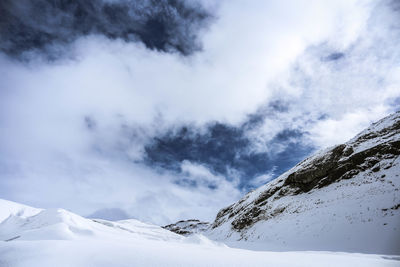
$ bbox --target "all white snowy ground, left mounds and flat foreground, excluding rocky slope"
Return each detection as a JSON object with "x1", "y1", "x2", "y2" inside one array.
[{"x1": 0, "y1": 200, "x2": 400, "y2": 267}]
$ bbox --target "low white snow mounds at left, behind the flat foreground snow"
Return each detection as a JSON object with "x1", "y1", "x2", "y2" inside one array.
[{"x1": 0, "y1": 199, "x2": 182, "y2": 241}]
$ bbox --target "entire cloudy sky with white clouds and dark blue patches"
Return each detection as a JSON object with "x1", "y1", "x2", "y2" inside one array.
[{"x1": 0, "y1": 0, "x2": 400, "y2": 225}]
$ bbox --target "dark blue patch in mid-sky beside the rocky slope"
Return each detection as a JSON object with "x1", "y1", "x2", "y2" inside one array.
[{"x1": 145, "y1": 111, "x2": 313, "y2": 189}]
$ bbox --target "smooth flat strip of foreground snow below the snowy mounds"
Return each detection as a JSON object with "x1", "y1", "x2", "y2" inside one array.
[{"x1": 0, "y1": 240, "x2": 399, "y2": 267}]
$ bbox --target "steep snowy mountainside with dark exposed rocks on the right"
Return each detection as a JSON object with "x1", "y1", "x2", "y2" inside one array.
[{"x1": 208, "y1": 112, "x2": 400, "y2": 254}]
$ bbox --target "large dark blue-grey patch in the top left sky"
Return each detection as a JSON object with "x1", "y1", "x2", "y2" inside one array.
[{"x1": 0, "y1": 0, "x2": 211, "y2": 58}]
